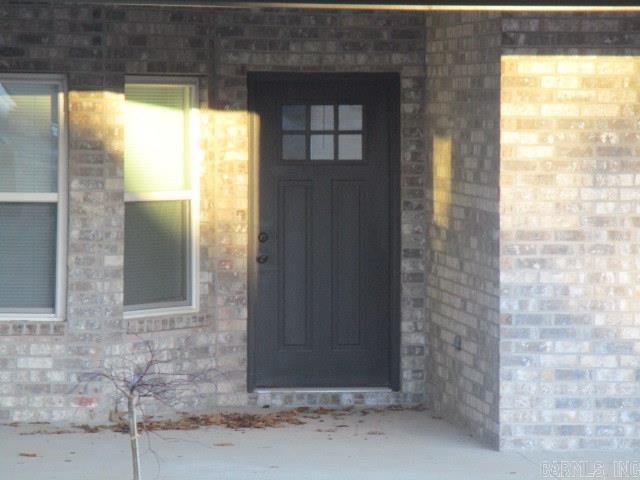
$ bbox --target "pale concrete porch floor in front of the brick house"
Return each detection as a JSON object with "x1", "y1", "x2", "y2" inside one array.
[{"x1": 0, "y1": 410, "x2": 639, "y2": 480}]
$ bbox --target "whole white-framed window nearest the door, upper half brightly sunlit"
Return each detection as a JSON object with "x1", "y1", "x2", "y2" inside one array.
[{"x1": 124, "y1": 79, "x2": 198, "y2": 316}]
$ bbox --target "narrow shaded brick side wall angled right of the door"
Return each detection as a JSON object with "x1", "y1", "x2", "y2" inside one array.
[{"x1": 426, "y1": 13, "x2": 501, "y2": 446}]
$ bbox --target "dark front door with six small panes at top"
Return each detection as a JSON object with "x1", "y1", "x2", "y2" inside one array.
[{"x1": 249, "y1": 75, "x2": 397, "y2": 388}]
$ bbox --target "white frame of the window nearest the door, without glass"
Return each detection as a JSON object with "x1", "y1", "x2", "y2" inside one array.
[{"x1": 123, "y1": 75, "x2": 202, "y2": 319}]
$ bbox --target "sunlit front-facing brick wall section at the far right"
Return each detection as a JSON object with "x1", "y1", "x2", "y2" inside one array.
[{"x1": 500, "y1": 14, "x2": 640, "y2": 449}]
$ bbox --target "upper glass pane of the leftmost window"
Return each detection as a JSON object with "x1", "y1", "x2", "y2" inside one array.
[{"x1": 0, "y1": 80, "x2": 60, "y2": 193}]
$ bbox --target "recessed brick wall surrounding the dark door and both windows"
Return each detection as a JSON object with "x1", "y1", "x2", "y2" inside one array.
[{"x1": 0, "y1": 2, "x2": 426, "y2": 422}]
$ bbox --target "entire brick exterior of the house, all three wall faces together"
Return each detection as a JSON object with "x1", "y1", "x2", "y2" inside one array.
[{"x1": 5, "y1": 2, "x2": 640, "y2": 448}]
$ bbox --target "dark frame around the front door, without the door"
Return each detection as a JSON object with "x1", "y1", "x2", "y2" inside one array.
[{"x1": 247, "y1": 71, "x2": 402, "y2": 393}]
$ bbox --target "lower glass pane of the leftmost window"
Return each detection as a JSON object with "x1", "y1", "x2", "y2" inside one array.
[{"x1": 0, "y1": 203, "x2": 57, "y2": 313}]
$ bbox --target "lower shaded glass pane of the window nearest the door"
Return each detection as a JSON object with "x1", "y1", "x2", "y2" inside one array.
[{"x1": 124, "y1": 200, "x2": 190, "y2": 306}]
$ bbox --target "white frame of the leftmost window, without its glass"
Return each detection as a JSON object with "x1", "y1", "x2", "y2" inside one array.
[{"x1": 0, "y1": 73, "x2": 68, "y2": 321}]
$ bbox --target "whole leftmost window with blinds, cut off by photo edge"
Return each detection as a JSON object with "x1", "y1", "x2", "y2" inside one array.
[{"x1": 0, "y1": 75, "x2": 66, "y2": 320}]
